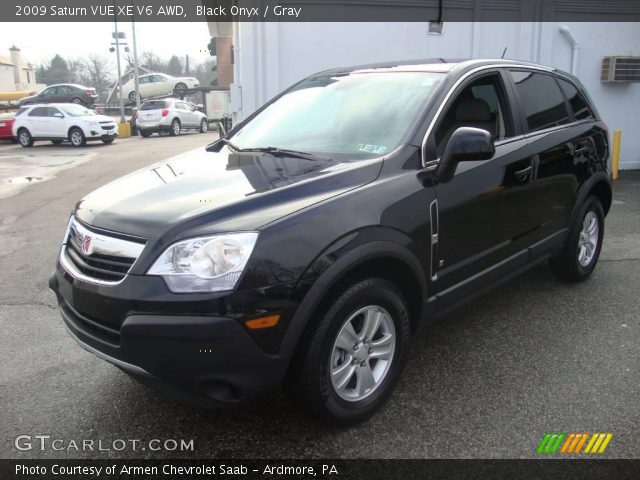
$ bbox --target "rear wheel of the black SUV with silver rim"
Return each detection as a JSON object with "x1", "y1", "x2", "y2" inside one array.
[{"x1": 549, "y1": 195, "x2": 604, "y2": 282}]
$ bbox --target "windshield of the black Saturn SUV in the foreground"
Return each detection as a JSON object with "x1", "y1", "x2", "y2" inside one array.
[{"x1": 230, "y1": 72, "x2": 443, "y2": 158}]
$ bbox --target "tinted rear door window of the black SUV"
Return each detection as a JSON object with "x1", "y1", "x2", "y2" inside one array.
[{"x1": 511, "y1": 71, "x2": 569, "y2": 132}]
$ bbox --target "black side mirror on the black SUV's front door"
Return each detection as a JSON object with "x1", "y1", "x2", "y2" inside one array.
[{"x1": 435, "y1": 127, "x2": 495, "y2": 182}]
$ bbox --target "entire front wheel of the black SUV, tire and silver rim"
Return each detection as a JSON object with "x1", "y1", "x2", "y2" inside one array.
[{"x1": 285, "y1": 278, "x2": 410, "y2": 425}]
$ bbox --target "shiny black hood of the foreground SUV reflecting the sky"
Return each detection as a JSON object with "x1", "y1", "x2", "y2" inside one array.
[{"x1": 75, "y1": 147, "x2": 382, "y2": 240}]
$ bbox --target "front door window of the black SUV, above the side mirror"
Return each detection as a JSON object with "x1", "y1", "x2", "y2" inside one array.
[{"x1": 435, "y1": 73, "x2": 513, "y2": 156}]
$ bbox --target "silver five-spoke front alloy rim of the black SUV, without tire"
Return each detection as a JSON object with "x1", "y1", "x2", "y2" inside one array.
[{"x1": 329, "y1": 305, "x2": 396, "y2": 402}]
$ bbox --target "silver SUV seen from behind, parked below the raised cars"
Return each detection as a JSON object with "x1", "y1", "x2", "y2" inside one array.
[{"x1": 136, "y1": 98, "x2": 209, "y2": 138}]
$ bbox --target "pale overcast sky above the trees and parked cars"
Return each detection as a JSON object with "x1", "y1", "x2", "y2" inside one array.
[{"x1": 0, "y1": 22, "x2": 210, "y2": 66}]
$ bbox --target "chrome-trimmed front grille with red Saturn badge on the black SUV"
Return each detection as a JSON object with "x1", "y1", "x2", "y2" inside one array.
[{"x1": 61, "y1": 220, "x2": 144, "y2": 283}]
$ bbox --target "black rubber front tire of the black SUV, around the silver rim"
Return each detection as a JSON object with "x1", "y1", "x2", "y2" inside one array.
[{"x1": 285, "y1": 278, "x2": 410, "y2": 425}]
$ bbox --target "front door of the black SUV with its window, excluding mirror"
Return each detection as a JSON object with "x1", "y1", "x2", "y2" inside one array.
[{"x1": 427, "y1": 71, "x2": 536, "y2": 307}]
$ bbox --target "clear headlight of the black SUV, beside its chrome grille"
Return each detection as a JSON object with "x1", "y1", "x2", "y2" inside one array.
[{"x1": 147, "y1": 232, "x2": 258, "y2": 293}]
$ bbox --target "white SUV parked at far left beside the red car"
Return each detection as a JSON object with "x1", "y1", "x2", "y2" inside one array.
[{"x1": 13, "y1": 103, "x2": 118, "y2": 147}]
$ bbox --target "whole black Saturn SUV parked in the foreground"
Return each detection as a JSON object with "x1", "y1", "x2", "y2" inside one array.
[{"x1": 50, "y1": 60, "x2": 611, "y2": 423}]
